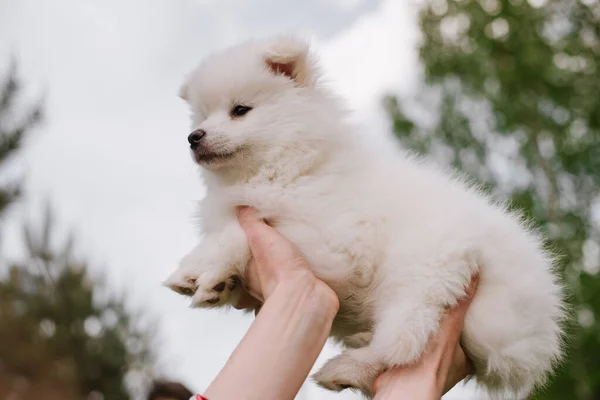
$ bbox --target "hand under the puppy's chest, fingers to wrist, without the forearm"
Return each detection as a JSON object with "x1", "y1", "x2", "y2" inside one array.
[{"x1": 234, "y1": 207, "x2": 324, "y2": 309}]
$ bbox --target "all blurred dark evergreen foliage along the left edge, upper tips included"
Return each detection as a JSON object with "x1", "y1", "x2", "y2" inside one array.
[{"x1": 0, "y1": 66, "x2": 153, "y2": 400}]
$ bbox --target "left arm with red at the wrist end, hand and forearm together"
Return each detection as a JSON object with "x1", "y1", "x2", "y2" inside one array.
[{"x1": 204, "y1": 208, "x2": 339, "y2": 399}]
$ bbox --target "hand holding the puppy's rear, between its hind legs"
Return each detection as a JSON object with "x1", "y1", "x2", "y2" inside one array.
[{"x1": 374, "y1": 276, "x2": 478, "y2": 400}]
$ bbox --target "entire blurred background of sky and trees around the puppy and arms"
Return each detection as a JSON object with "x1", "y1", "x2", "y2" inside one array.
[{"x1": 0, "y1": 0, "x2": 600, "y2": 400}]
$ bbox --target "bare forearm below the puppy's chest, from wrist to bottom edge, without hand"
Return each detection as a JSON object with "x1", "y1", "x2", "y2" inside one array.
[{"x1": 205, "y1": 276, "x2": 339, "y2": 400}]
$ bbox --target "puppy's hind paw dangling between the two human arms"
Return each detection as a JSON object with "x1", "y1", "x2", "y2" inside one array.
[{"x1": 312, "y1": 349, "x2": 382, "y2": 398}]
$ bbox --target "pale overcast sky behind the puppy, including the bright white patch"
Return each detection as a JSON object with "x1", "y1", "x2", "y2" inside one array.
[{"x1": 0, "y1": 0, "x2": 480, "y2": 400}]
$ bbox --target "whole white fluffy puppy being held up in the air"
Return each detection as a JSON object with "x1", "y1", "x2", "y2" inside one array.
[{"x1": 166, "y1": 36, "x2": 564, "y2": 399}]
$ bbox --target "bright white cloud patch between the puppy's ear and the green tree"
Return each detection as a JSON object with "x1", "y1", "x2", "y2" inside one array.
[{"x1": 321, "y1": 0, "x2": 418, "y2": 111}]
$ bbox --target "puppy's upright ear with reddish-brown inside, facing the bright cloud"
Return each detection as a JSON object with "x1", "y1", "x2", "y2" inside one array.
[{"x1": 265, "y1": 36, "x2": 318, "y2": 87}]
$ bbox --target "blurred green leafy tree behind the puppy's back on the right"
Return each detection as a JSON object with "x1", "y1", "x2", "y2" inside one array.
[{"x1": 385, "y1": 0, "x2": 600, "y2": 400}]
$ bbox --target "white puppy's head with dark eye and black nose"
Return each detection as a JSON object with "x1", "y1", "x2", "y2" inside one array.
[{"x1": 180, "y1": 36, "x2": 338, "y2": 170}]
